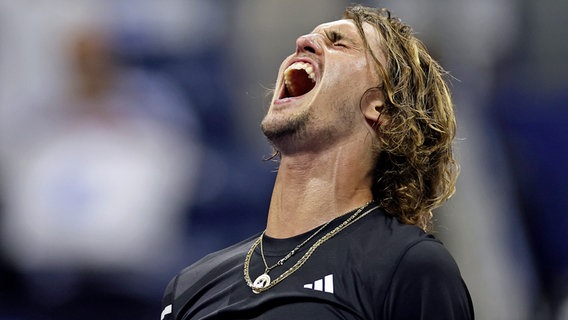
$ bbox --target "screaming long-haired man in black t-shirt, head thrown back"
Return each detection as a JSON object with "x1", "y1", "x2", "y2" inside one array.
[{"x1": 162, "y1": 6, "x2": 473, "y2": 320}]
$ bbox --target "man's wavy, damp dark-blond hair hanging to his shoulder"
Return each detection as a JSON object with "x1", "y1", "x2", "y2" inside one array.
[{"x1": 343, "y1": 5, "x2": 459, "y2": 230}]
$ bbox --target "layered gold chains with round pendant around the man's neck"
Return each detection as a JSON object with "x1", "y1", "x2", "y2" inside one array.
[{"x1": 243, "y1": 200, "x2": 375, "y2": 294}]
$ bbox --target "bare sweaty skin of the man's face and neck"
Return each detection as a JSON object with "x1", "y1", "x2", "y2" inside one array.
[{"x1": 262, "y1": 19, "x2": 384, "y2": 238}]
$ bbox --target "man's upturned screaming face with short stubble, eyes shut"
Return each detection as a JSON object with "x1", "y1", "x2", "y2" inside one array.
[{"x1": 261, "y1": 20, "x2": 384, "y2": 151}]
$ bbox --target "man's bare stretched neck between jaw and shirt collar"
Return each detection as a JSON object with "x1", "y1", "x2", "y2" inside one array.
[{"x1": 266, "y1": 136, "x2": 374, "y2": 238}]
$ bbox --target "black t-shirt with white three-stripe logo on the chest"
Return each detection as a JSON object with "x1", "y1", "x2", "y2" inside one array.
[{"x1": 161, "y1": 208, "x2": 474, "y2": 320}]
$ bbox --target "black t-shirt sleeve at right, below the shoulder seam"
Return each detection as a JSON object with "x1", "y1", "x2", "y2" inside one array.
[{"x1": 384, "y1": 240, "x2": 474, "y2": 320}]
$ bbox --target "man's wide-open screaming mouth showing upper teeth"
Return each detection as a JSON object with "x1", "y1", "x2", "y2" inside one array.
[{"x1": 280, "y1": 62, "x2": 316, "y2": 99}]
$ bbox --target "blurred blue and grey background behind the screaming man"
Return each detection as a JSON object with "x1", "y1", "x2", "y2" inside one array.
[{"x1": 0, "y1": 0, "x2": 568, "y2": 320}]
